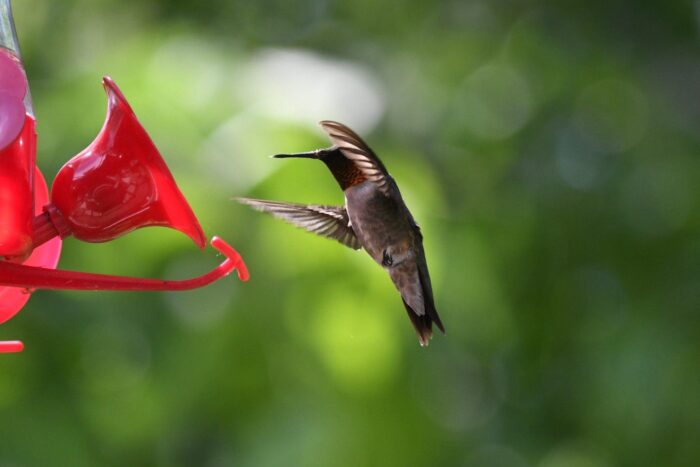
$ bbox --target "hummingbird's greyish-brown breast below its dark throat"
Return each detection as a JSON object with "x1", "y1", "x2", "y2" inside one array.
[{"x1": 345, "y1": 181, "x2": 412, "y2": 264}]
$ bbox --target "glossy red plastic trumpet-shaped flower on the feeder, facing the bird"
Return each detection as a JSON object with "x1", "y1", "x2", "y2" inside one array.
[{"x1": 33, "y1": 77, "x2": 211, "y2": 248}]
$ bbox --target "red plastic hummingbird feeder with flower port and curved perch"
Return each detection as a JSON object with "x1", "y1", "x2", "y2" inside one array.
[{"x1": 0, "y1": 0, "x2": 249, "y2": 353}]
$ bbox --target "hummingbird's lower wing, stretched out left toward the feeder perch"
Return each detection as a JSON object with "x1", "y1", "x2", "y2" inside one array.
[{"x1": 236, "y1": 198, "x2": 362, "y2": 250}]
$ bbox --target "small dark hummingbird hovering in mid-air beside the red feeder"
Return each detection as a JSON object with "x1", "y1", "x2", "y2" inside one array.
[{"x1": 236, "y1": 120, "x2": 445, "y2": 346}]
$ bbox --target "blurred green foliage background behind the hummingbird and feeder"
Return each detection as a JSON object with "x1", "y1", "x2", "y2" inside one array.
[{"x1": 0, "y1": 0, "x2": 700, "y2": 467}]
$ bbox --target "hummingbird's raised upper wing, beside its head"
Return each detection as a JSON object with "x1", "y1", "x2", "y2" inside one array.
[{"x1": 321, "y1": 120, "x2": 394, "y2": 196}]
